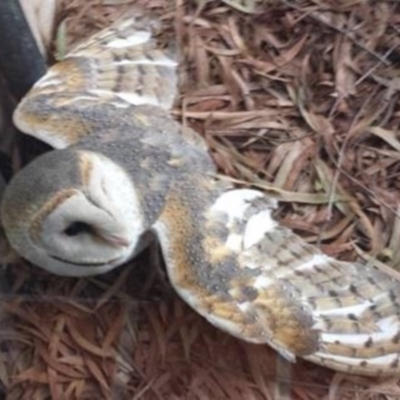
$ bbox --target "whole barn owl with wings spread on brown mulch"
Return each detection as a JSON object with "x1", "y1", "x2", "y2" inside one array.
[{"x1": 1, "y1": 19, "x2": 400, "y2": 376}]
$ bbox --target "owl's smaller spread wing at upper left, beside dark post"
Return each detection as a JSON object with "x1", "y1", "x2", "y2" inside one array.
[{"x1": 14, "y1": 18, "x2": 177, "y2": 148}]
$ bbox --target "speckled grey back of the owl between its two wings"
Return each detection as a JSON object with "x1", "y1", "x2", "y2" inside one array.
[{"x1": 71, "y1": 106, "x2": 216, "y2": 227}]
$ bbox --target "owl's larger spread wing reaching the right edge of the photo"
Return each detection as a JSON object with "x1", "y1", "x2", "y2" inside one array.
[{"x1": 154, "y1": 179, "x2": 400, "y2": 375}]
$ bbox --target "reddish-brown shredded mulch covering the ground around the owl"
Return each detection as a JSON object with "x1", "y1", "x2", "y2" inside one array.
[{"x1": 0, "y1": 0, "x2": 400, "y2": 400}]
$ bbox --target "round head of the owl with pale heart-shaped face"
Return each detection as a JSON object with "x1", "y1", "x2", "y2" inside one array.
[{"x1": 1, "y1": 149, "x2": 146, "y2": 276}]
